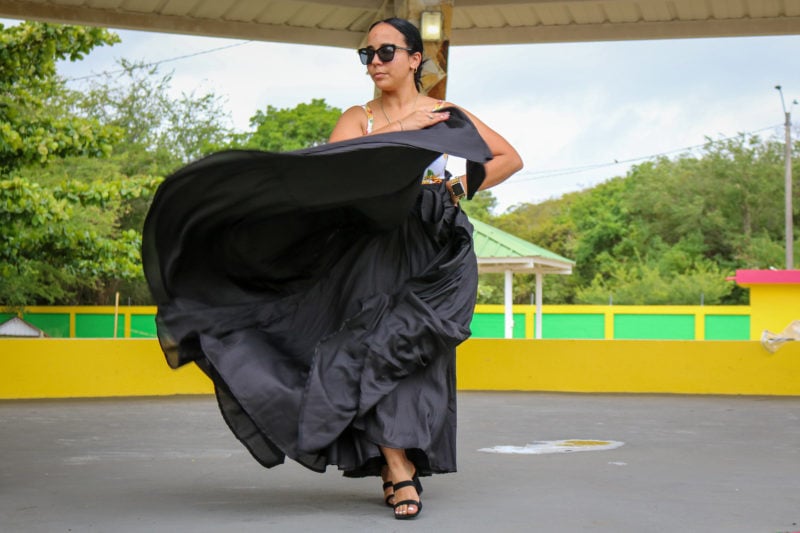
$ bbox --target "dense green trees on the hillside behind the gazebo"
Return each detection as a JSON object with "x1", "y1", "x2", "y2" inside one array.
[{"x1": 485, "y1": 135, "x2": 798, "y2": 305}]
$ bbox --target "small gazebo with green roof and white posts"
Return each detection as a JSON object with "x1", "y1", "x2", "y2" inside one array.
[{"x1": 471, "y1": 220, "x2": 575, "y2": 339}]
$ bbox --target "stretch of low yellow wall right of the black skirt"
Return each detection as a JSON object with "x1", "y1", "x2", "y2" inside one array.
[{"x1": 458, "y1": 339, "x2": 800, "y2": 396}]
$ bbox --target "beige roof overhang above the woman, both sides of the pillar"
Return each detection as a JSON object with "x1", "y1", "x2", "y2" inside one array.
[{"x1": 0, "y1": 0, "x2": 800, "y2": 48}]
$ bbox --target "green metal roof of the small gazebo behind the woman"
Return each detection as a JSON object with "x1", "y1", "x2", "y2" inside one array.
[{"x1": 470, "y1": 219, "x2": 575, "y2": 274}]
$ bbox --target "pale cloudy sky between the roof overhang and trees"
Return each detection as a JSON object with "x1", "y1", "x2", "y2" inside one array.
[{"x1": 15, "y1": 21, "x2": 800, "y2": 214}]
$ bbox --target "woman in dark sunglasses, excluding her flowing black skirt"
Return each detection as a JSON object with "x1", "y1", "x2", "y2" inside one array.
[{"x1": 330, "y1": 18, "x2": 522, "y2": 517}]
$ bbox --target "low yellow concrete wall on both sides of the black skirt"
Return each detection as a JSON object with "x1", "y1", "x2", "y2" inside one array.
[{"x1": 0, "y1": 339, "x2": 800, "y2": 399}]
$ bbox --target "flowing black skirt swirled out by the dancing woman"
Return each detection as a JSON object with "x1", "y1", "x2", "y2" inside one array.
[{"x1": 142, "y1": 109, "x2": 490, "y2": 476}]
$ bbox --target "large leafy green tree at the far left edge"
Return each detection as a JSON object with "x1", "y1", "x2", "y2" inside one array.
[{"x1": 0, "y1": 23, "x2": 180, "y2": 306}]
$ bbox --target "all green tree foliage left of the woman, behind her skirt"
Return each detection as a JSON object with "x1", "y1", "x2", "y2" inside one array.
[{"x1": 0, "y1": 23, "x2": 340, "y2": 306}]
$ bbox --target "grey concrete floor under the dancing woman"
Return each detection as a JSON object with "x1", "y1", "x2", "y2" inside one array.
[{"x1": 0, "y1": 393, "x2": 800, "y2": 533}]
